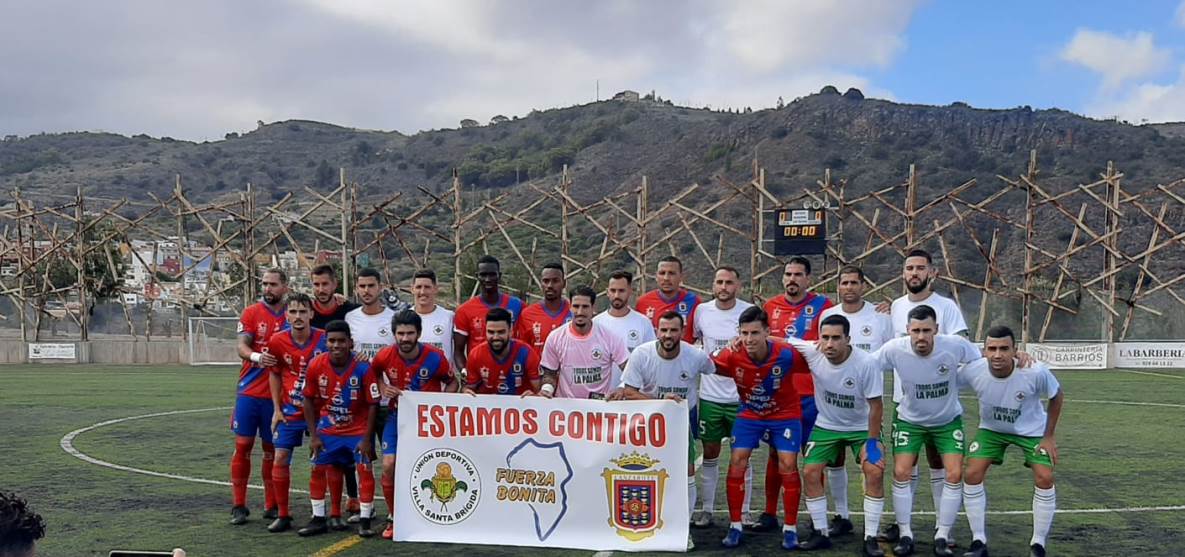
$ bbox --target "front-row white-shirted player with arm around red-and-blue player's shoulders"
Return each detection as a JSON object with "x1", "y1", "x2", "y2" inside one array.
[{"x1": 787, "y1": 314, "x2": 885, "y2": 557}]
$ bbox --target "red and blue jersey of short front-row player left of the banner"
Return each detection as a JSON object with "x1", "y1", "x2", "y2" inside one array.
[{"x1": 303, "y1": 353, "x2": 379, "y2": 436}]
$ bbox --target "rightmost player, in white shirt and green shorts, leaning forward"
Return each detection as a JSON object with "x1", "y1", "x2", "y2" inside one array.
[{"x1": 959, "y1": 327, "x2": 1064, "y2": 557}]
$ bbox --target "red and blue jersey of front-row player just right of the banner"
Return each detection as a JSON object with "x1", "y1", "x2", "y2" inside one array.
[{"x1": 712, "y1": 340, "x2": 811, "y2": 421}]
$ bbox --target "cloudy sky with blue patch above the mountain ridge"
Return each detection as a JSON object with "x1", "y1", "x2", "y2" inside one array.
[{"x1": 0, "y1": 0, "x2": 1185, "y2": 141}]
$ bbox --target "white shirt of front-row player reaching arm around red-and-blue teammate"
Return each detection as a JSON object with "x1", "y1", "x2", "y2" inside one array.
[{"x1": 786, "y1": 338, "x2": 885, "y2": 431}]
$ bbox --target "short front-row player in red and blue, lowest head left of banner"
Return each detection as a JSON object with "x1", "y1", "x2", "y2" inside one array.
[{"x1": 296, "y1": 321, "x2": 379, "y2": 538}]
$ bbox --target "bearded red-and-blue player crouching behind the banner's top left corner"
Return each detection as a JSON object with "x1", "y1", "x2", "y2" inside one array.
[{"x1": 372, "y1": 309, "x2": 457, "y2": 539}]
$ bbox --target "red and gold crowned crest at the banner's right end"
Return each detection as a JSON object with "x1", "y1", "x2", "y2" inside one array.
[{"x1": 601, "y1": 453, "x2": 670, "y2": 542}]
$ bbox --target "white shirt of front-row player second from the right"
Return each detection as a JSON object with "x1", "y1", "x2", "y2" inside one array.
[{"x1": 873, "y1": 334, "x2": 982, "y2": 428}]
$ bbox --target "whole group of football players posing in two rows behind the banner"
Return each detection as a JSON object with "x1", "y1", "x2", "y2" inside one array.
[{"x1": 230, "y1": 250, "x2": 1063, "y2": 556}]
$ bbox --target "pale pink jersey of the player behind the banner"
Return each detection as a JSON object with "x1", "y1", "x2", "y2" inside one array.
[{"x1": 539, "y1": 322, "x2": 629, "y2": 398}]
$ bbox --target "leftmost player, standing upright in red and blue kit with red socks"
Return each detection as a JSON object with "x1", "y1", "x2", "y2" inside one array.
[{"x1": 230, "y1": 269, "x2": 288, "y2": 525}]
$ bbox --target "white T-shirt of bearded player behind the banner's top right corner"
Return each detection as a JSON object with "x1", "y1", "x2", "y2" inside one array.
[{"x1": 621, "y1": 340, "x2": 710, "y2": 409}]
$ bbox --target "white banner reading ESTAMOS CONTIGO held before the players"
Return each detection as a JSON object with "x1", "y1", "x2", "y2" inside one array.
[{"x1": 395, "y1": 391, "x2": 690, "y2": 551}]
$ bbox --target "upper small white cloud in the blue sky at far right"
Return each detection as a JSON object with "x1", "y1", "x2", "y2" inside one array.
[{"x1": 1061, "y1": 28, "x2": 1172, "y2": 91}]
